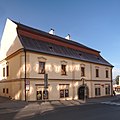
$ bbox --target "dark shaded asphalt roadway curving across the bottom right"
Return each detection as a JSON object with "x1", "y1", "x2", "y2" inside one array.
[{"x1": 30, "y1": 103, "x2": 120, "y2": 120}]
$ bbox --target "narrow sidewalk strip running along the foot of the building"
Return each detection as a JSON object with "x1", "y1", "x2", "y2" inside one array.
[{"x1": 0, "y1": 96, "x2": 120, "y2": 108}]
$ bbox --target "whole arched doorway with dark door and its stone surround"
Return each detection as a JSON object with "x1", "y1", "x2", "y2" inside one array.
[{"x1": 78, "y1": 85, "x2": 89, "y2": 100}]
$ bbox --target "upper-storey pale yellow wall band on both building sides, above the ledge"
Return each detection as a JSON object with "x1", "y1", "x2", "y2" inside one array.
[{"x1": 0, "y1": 48, "x2": 111, "y2": 84}]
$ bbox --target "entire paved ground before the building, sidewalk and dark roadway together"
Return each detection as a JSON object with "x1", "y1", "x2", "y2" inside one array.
[{"x1": 0, "y1": 96, "x2": 120, "y2": 120}]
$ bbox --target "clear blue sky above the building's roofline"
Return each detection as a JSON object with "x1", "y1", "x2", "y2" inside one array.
[{"x1": 0, "y1": 0, "x2": 120, "y2": 78}]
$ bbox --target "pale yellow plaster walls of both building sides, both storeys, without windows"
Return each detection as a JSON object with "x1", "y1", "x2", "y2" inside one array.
[{"x1": 1, "y1": 52, "x2": 111, "y2": 101}]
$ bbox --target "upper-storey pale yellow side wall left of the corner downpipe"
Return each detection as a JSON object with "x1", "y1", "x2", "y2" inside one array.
[{"x1": 0, "y1": 52, "x2": 25, "y2": 80}]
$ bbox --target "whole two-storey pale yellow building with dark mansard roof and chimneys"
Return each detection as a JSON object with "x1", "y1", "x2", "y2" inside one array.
[{"x1": 0, "y1": 19, "x2": 113, "y2": 101}]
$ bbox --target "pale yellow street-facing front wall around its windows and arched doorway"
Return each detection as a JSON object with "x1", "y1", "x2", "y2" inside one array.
[{"x1": 23, "y1": 53, "x2": 111, "y2": 99}]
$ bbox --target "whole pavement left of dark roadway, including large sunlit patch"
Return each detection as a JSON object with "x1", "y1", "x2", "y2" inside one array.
[{"x1": 0, "y1": 96, "x2": 120, "y2": 119}]
